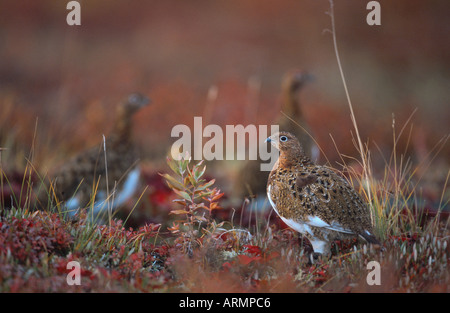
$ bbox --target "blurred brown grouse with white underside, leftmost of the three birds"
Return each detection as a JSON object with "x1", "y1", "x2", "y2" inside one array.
[{"x1": 40, "y1": 93, "x2": 150, "y2": 217}]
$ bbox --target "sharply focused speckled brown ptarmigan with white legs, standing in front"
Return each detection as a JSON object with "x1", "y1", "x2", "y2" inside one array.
[{"x1": 266, "y1": 132, "x2": 380, "y2": 261}]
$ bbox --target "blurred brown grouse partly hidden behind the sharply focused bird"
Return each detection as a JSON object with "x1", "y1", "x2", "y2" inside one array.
[{"x1": 236, "y1": 70, "x2": 319, "y2": 199}]
